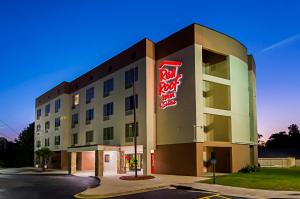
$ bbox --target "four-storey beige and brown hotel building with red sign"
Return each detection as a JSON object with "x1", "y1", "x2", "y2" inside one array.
[{"x1": 35, "y1": 24, "x2": 257, "y2": 176}]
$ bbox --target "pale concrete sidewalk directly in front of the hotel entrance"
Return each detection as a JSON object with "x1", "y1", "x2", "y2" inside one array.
[{"x1": 75, "y1": 174, "x2": 207, "y2": 198}]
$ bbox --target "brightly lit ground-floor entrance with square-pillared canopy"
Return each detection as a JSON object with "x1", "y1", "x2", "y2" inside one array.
[{"x1": 68, "y1": 145, "x2": 147, "y2": 176}]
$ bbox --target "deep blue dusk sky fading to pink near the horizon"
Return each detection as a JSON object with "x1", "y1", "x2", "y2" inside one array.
[{"x1": 0, "y1": 0, "x2": 300, "y2": 139}]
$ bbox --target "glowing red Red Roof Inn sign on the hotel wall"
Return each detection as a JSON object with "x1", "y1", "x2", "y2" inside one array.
[{"x1": 158, "y1": 61, "x2": 182, "y2": 109}]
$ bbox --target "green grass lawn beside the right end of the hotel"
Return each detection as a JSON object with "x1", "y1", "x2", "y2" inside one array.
[{"x1": 201, "y1": 167, "x2": 300, "y2": 191}]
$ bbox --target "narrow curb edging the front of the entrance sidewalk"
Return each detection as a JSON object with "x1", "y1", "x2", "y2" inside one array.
[{"x1": 74, "y1": 185, "x2": 170, "y2": 199}]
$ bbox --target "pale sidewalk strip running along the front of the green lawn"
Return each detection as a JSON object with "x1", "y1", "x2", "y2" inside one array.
[{"x1": 180, "y1": 183, "x2": 300, "y2": 198}]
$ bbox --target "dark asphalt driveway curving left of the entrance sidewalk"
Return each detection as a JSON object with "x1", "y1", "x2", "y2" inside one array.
[{"x1": 0, "y1": 175, "x2": 99, "y2": 199}]
